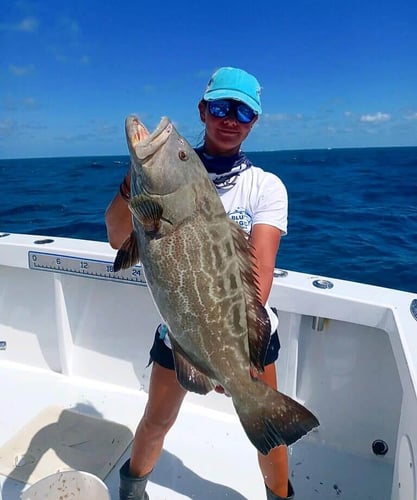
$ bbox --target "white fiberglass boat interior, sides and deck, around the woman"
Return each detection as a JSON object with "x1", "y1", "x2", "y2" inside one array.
[{"x1": 0, "y1": 233, "x2": 417, "y2": 500}]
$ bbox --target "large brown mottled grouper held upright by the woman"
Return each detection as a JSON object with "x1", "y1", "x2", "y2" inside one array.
[{"x1": 114, "y1": 116, "x2": 319, "y2": 454}]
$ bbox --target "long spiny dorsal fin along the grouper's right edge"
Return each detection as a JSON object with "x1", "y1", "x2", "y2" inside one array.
[{"x1": 230, "y1": 220, "x2": 271, "y2": 372}]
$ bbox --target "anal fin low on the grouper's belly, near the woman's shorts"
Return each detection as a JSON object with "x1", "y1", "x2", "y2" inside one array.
[{"x1": 170, "y1": 336, "x2": 215, "y2": 394}]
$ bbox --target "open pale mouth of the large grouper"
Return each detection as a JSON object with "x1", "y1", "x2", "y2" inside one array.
[{"x1": 125, "y1": 115, "x2": 172, "y2": 161}]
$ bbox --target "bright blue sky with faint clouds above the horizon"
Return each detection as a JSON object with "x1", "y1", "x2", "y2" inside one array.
[{"x1": 0, "y1": 0, "x2": 417, "y2": 158}]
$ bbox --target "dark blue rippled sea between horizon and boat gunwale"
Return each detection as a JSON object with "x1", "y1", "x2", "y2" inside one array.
[{"x1": 0, "y1": 147, "x2": 417, "y2": 292}]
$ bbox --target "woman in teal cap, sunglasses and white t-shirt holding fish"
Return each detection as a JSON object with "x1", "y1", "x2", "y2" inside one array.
[{"x1": 106, "y1": 67, "x2": 318, "y2": 500}]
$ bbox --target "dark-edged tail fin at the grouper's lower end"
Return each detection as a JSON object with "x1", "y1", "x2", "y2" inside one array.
[{"x1": 233, "y1": 378, "x2": 319, "y2": 455}]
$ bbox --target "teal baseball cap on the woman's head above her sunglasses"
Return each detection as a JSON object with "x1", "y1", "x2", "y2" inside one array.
[{"x1": 203, "y1": 67, "x2": 262, "y2": 115}]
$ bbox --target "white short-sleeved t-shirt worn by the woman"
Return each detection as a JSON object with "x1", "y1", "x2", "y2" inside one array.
[{"x1": 164, "y1": 166, "x2": 288, "y2": 347}]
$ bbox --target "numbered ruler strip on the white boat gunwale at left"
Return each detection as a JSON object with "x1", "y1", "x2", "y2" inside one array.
[{"x1": 28, "y1": 251, "x2": 146, "y2": 285}]
